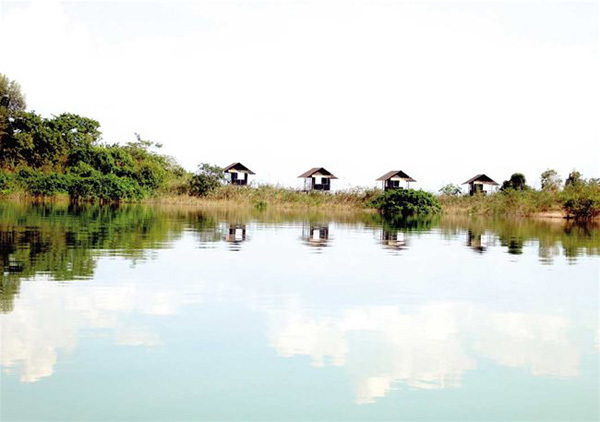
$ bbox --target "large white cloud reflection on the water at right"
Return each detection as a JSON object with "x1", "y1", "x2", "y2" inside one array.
[{"x1": 271, "y1": 303, "x2": 582, "y2": 404}]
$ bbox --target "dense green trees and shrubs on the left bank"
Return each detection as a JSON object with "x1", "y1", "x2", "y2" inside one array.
[{"x1": 0, "y1": 75, "x2": 190, "y2": 202}]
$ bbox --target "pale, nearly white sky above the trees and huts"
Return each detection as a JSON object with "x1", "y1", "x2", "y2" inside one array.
[{"x1": 0, "y1": 0, "x2": 600, "y2": 191}]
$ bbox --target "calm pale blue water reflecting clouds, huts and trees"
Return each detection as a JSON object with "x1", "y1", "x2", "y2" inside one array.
[{"x1": 0, "y1": 204, "x2": 600, "y2": 421}]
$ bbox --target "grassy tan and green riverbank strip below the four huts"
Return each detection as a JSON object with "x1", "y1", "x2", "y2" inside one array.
[{"x1": 0, "y1": 185, "x2": 600, "y2": 221}]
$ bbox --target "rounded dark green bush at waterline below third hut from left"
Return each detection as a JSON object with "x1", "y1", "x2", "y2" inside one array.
[{"x1": 371, "y1": 189, "x2": 442, "y2": 218}]
